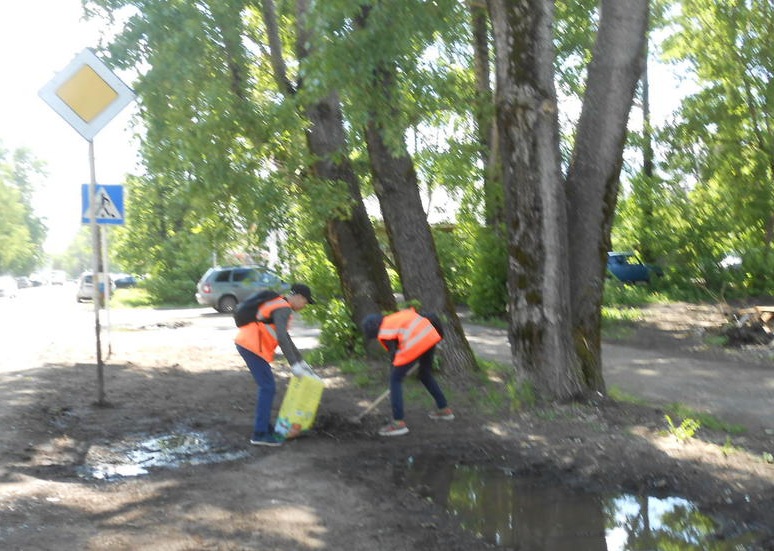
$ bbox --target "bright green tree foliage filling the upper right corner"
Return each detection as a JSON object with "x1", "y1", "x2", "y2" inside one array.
[{"x1": 628, "y1": 0, "x2": 774, "y2": 298}]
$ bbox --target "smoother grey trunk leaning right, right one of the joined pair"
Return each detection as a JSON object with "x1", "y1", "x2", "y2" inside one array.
[{"x1": 567, "y1": 0, "x2": 648, "y2": 392}]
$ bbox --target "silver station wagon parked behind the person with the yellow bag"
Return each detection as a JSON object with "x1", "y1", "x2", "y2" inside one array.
[{"x1": 196, "y1": 266, "x2": 290, "y2": 313}]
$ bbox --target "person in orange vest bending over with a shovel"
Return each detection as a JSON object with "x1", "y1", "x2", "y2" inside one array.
[{"x1": 362, "y1": 308, "x2": 454, "y2": 436}]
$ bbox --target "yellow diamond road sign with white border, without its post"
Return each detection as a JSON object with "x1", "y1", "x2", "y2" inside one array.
[{"x1": 39, "y1": 48, "x2": 134, "y2": 141}]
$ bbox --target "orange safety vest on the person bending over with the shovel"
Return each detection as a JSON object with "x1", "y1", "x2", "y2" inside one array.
[{"x1": 376, "y1": 308, "x2": 442, "y2": 366}]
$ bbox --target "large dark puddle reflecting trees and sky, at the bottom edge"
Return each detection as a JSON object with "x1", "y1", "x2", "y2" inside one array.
[{"x1": 394, "y1": 457, "x2": 755, "y2": 551}]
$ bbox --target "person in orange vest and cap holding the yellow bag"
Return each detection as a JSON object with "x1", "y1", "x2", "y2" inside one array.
[{"x1": 234, "y1": 283, "x2": 317, "y2": 446}]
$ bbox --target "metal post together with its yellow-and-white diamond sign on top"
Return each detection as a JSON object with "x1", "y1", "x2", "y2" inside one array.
[{"x1": 39, "y1": 48, "x2": 134, "y2": 405}]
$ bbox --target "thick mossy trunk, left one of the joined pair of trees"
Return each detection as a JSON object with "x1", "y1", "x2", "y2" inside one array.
[{"x1": 487, "y1": 0, "x2": 583, "y2": 399}]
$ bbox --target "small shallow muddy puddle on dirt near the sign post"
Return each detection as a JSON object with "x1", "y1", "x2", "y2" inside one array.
[{"x1": 78, "y1": 430, "x2": 249, "y2": 480}]
